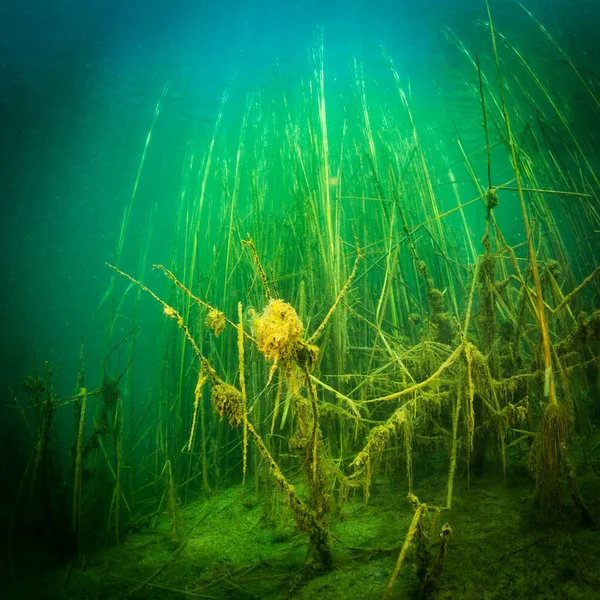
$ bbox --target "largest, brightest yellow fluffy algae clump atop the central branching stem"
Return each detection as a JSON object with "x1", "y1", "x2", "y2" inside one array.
[{"x1": 254, "y1": 300, "x2": 304, "y2": 364}]
